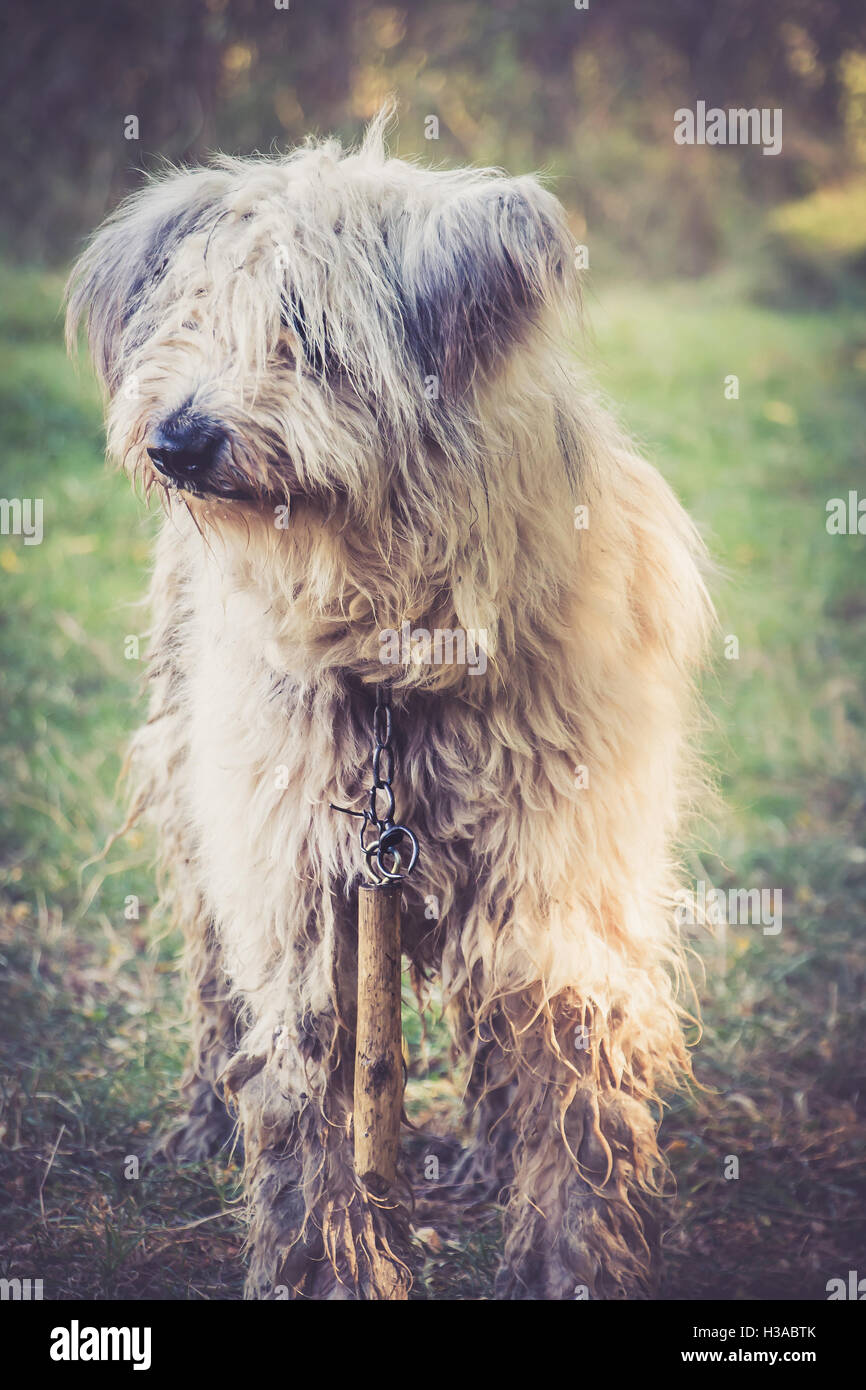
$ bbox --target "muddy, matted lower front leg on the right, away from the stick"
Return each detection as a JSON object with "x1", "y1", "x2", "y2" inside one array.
[{"x1": 461, "y1": 991, "x2": 664, "y2": 1300}]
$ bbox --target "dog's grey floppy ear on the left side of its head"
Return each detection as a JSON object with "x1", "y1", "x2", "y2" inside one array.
[{"x1": 67, "y1": 170, "x2": 225, "y2": 391}]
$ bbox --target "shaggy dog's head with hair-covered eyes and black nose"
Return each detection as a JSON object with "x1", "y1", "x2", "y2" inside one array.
[{"x1": 68, "y1": 122, "x2": 573, "y2": 523}]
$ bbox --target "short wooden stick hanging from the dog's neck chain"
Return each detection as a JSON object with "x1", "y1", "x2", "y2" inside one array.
[{"x1": 354, "y1": 883, "x2": 403, "y2": 1197}]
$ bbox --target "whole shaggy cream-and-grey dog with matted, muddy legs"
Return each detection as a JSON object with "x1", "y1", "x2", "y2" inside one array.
[{"x1": 70, "y1": 111, "x2": 710, "y2": 1300}]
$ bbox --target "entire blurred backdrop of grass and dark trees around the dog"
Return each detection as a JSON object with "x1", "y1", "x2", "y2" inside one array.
[{"x1": 0, "y1": 0, "x2": 866, "y2": 1298}]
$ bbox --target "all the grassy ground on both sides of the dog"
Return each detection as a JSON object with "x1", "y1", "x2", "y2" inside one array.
[{"x1": 0, "y1": 268, "x2": 866, "y2": 1298}]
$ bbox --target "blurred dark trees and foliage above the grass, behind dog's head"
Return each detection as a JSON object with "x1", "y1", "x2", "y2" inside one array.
[{"x1": 0, "y1": 0, "x2": 866, "y2": 271}]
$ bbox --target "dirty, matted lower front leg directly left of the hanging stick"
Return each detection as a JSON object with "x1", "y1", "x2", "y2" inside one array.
[{"x1": 224, "y1": 906, "x2": 411, "y2": 1300}]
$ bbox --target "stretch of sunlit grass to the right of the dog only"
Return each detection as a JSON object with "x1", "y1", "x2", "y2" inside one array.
[{"x1": 594, "y1": 281, "x2": 866, "y2": 1298}]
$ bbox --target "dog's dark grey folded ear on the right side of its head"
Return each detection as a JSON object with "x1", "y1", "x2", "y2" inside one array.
[{"x1": 402, "y1": 178, "x2": 575, "y2": 395}]
